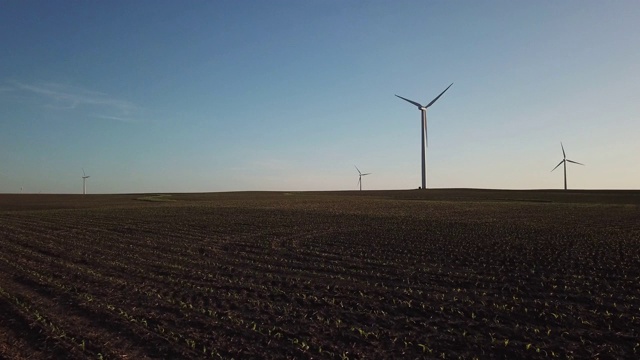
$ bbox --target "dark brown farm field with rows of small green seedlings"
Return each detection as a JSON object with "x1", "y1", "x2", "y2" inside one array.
[{"x1": 0, "y1": 189, "x2": 640, "y2": 359}]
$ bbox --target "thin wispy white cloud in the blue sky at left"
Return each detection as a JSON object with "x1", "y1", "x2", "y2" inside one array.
[{"x1": 7, "y1": 82, "x2": 142, "y2": 122}]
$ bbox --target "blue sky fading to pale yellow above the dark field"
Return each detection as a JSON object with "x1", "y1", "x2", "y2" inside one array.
[{"x1": 0, "y1": 0, "x2": 640, "y2": 193}]
